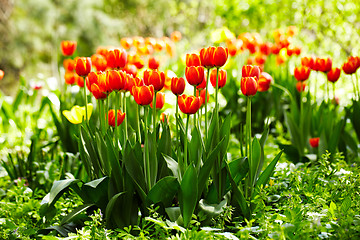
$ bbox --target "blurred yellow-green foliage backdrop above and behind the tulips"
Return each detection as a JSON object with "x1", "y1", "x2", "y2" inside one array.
[{"x1": 0, "y1": 0, "x2": 360, "y2": 95}]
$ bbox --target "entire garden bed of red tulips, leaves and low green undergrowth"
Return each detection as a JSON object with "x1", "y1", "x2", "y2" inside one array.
[{"x1": 0, "y1": 0, "x2": 360, "y2": 239}]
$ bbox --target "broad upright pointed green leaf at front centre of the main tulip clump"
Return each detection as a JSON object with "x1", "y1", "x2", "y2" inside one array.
[{"x1": 179, "y1": 164, "x2": 198, "y2": 227}]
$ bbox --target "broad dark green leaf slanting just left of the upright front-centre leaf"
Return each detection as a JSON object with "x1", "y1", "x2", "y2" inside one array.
[{"x1": 147, "y1": 176, "x2": 180, "y2": 207}]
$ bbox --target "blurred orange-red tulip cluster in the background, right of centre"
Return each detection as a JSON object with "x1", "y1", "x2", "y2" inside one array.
[{"x1": 226, "y1": 26, "x2": 301, "y2": 70}]
